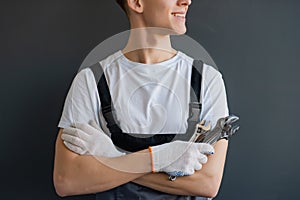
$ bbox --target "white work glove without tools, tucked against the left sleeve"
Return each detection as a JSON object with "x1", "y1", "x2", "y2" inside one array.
[{"x1": 61, "y1": 121, "x2": 125, "y2": 157}]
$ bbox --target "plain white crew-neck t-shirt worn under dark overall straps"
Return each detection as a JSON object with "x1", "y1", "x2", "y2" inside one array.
[{"x1": 58, "y1": 51, "x2": 228, "y2": 135}]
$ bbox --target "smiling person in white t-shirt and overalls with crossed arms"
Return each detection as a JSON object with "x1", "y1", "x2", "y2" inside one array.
[{"x1": 54, "y1": 0, "x2": 228, "y2": 199}]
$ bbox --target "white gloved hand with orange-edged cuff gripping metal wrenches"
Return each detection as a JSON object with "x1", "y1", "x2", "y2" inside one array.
[{"x1": 149, "y1": 141, "x2": 214, "y2": 176}]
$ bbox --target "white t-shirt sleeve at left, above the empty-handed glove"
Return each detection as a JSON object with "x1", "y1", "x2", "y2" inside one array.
[{"x1": 58, "y1": 68, "x2": 100, "y2": 128}]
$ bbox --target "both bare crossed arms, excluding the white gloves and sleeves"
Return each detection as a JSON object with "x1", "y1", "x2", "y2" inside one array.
[{"x1": 53, "y1": 129, "x2": 228, "y2": 197}]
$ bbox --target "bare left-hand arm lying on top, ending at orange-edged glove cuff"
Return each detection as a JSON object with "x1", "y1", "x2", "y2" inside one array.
[{"x1": 53, "y1": 131, "x2": 151, "y2": 196}]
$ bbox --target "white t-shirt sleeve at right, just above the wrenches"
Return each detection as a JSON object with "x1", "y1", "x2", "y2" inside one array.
[{"x1": 200, "y1": 64, "x2": 229, "y2": 127}]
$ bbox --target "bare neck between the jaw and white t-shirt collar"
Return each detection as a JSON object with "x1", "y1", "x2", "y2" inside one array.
[{"x1": 122, "y1": 28, "x2": 176, "y2": 64}]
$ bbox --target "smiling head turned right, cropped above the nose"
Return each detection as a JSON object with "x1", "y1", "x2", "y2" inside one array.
[{"x1": 116, "y1": 0, "x2": 191, "y2": 34}]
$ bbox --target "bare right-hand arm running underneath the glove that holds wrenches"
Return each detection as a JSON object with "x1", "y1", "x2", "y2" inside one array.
[{"x1": 133, "y1": 140, "x2": 228, "y2": 197}]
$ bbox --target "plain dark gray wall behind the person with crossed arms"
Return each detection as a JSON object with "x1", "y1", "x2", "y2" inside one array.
[{"x1": 0, "y1": 0, "x2": 300, "y2": 200}]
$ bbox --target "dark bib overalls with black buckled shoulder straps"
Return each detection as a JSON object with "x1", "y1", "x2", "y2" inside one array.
[{"x1": 90, "y1": 60, "x2": 210, "y2": 200}]
